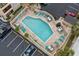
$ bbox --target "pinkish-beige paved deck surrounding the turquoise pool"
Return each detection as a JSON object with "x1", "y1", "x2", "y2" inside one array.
[{"x1": 11, "y1": 10, "x2": 70, "y2": 53}]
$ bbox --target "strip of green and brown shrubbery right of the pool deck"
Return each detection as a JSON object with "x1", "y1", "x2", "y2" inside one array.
[{"x1": 57, "y1": 22, "x2": 79, "y2": 56}]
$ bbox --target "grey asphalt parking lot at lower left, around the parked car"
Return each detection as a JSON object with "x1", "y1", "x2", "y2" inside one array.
[{"x1": 0, "y1": 30, "x2": 46, "y2": 56}]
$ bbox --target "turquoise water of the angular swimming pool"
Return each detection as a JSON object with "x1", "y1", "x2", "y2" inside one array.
[{"x1": 22, "y1": 16, "x2": 53, "y2": 42}]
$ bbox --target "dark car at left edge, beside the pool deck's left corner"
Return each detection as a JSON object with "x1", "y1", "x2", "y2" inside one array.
[{"x1": 0, "y1": 18, "x2": 11, "y2": 39}]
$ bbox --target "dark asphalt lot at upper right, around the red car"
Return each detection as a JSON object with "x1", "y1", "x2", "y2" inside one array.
[{"x1": 42, "y1": 3, "x2": 79, "y2": 24}]
